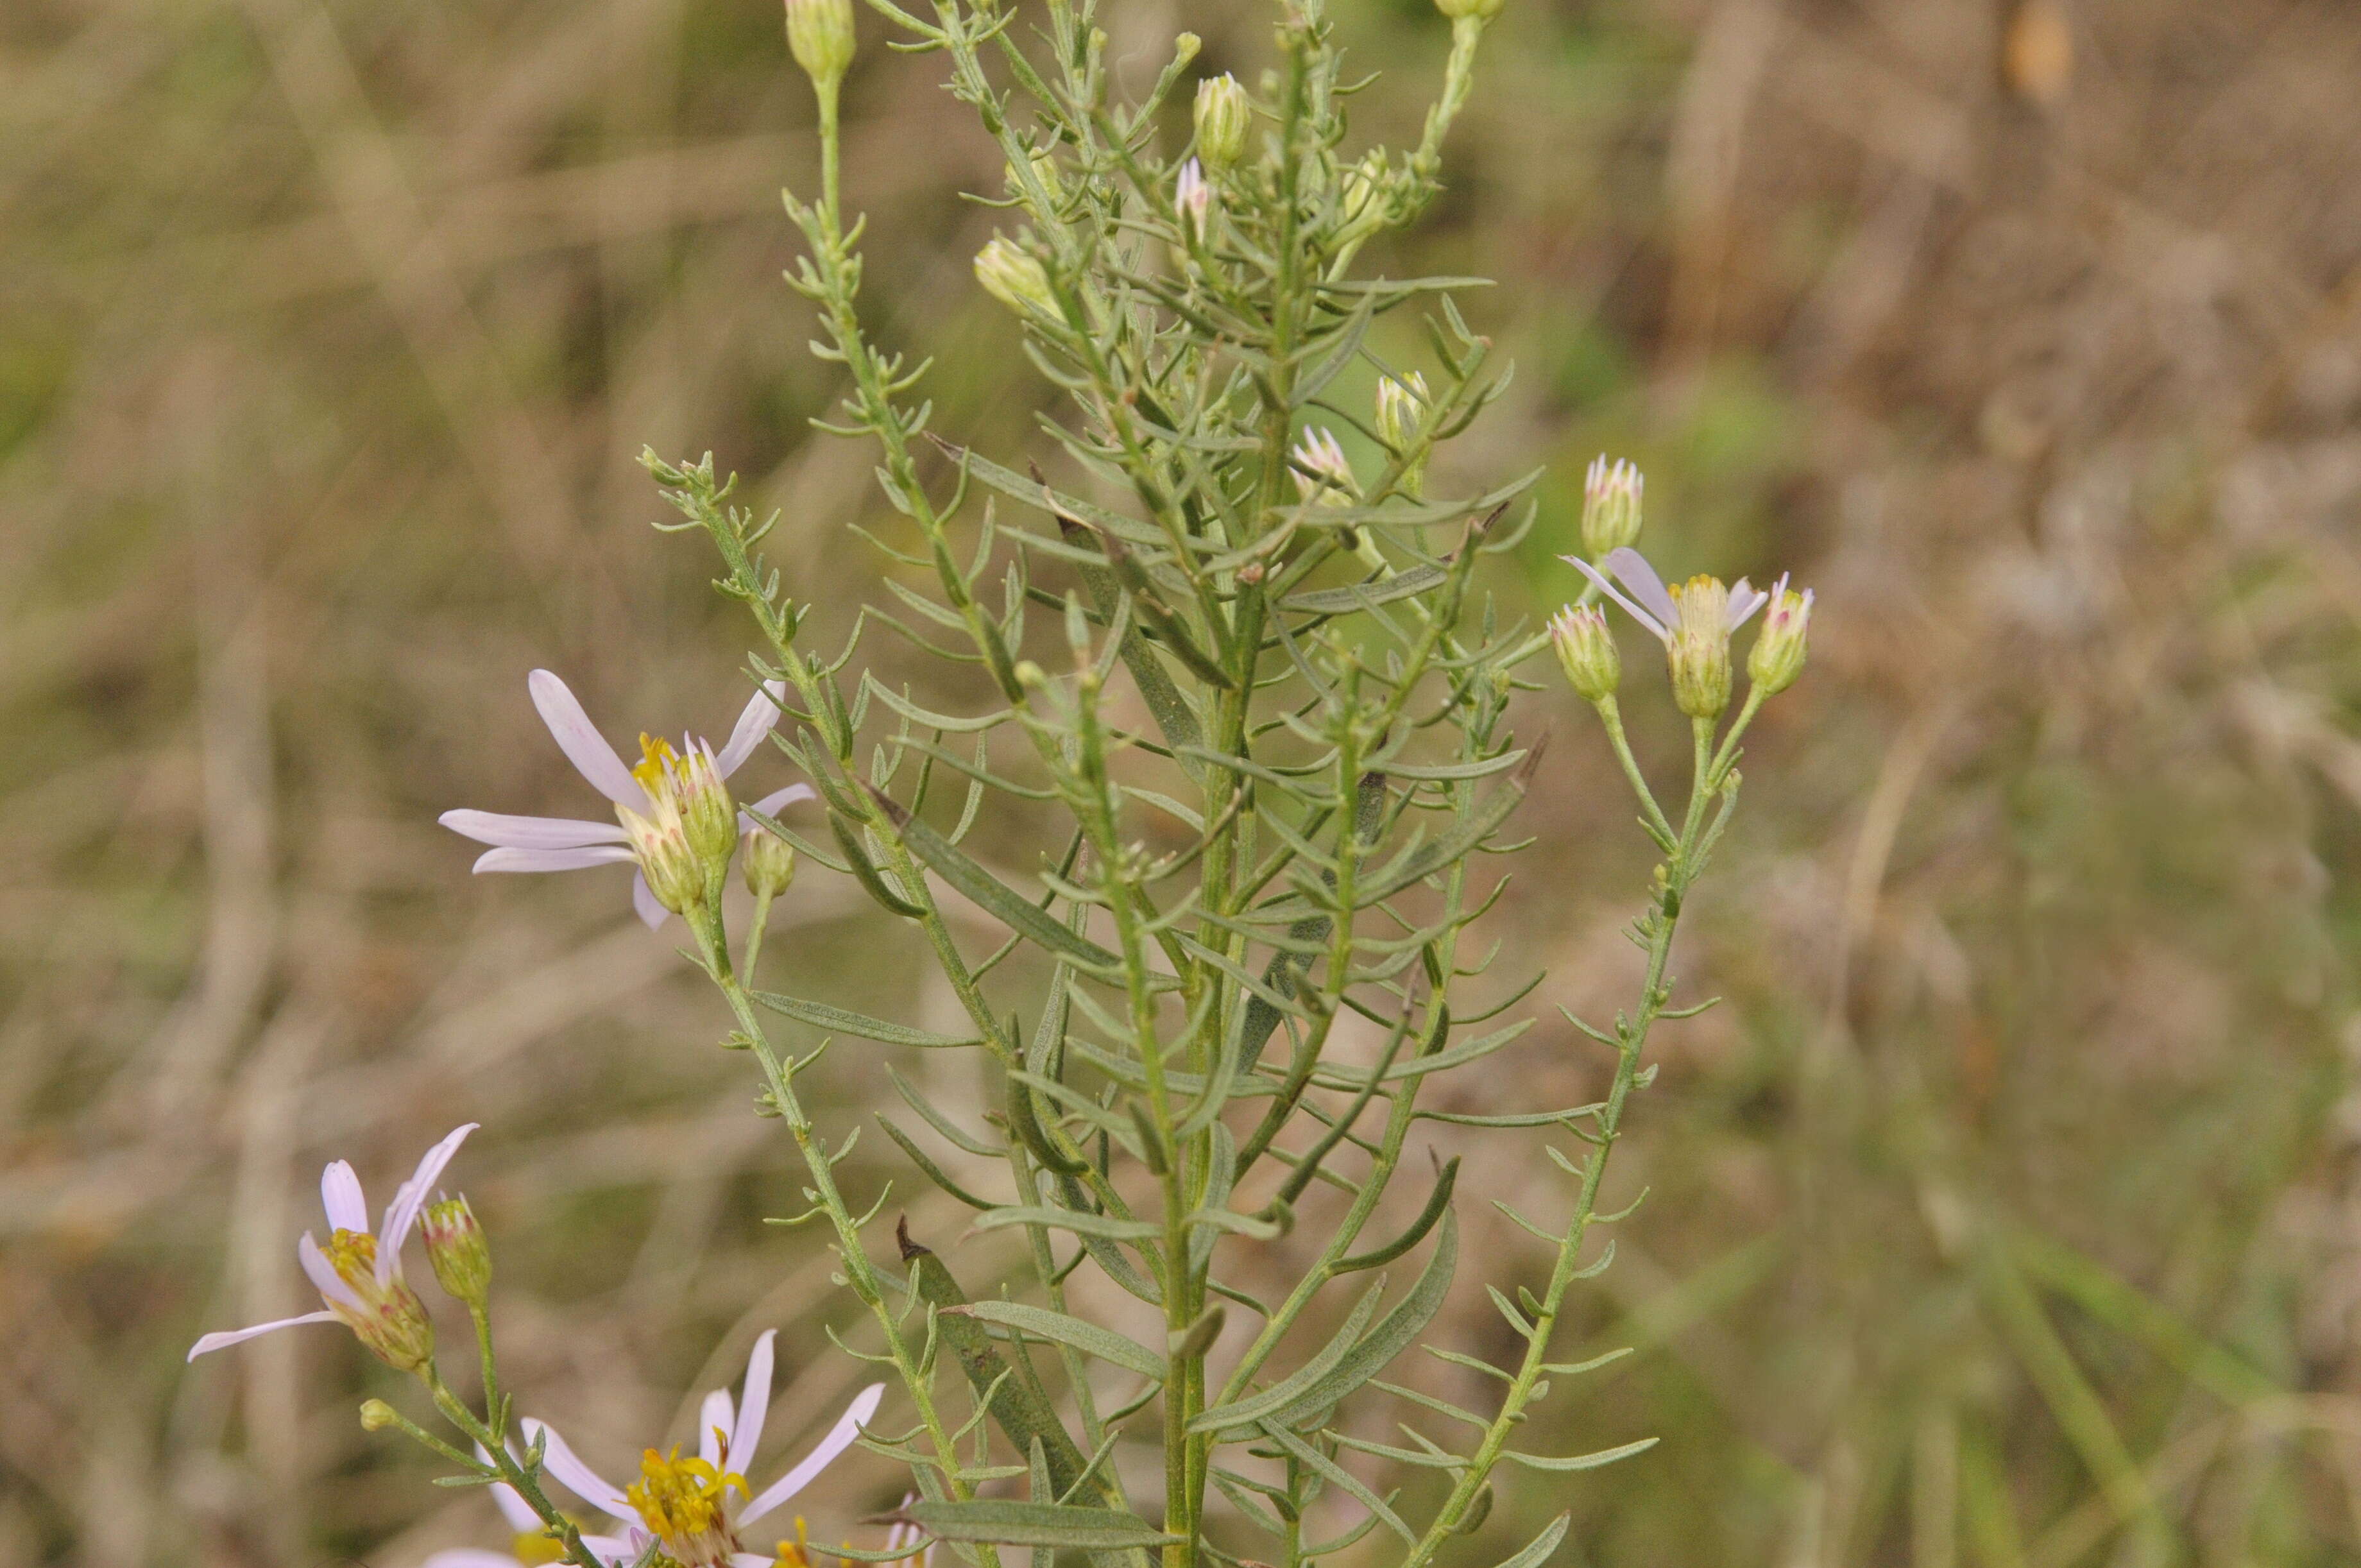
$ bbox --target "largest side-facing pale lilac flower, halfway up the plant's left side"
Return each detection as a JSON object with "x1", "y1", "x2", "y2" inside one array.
[{"x1": 439, "y1": 670, "x2": 812, "y2": 930}]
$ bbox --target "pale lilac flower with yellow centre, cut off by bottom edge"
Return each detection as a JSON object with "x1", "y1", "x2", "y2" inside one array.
[{"x1": 524, "y1": 1332, "x2": 885, "y2": 1568}]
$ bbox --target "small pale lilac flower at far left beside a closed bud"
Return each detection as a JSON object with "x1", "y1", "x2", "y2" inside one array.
[{"x1": 189, "y1": 1121, "x2": 477, "y2": 1372}]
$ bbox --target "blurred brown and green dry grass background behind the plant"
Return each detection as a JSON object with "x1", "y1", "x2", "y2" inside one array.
[{"x1": 0, "y1": 0, "x2": 2361, "y2": 1568}]
